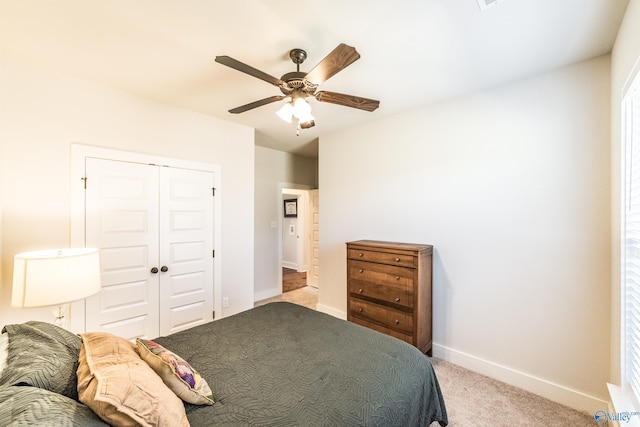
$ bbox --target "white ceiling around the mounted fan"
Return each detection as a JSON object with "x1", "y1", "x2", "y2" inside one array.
[{"x1": 0, "y1": 0, "x2": 629, "y2": 156}]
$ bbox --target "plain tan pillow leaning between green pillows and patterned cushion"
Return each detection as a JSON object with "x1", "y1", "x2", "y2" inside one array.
[{"x1": 78, "y1": 332, "x2": 189, "y2": 426}]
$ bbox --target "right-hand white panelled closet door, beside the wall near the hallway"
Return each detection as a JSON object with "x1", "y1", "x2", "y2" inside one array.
[{"x1": 160, "y1": 168, "x2": 214, "y2": 335}]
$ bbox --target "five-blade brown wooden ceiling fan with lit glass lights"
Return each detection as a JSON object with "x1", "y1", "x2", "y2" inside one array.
[{"x1": 216, "y1": 43, "x2": 380, "y2": 131}]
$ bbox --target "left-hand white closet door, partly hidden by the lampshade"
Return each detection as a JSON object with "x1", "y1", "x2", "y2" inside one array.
[{"x1": 85, "y1": 158, "x2": 159, "y2": 339}]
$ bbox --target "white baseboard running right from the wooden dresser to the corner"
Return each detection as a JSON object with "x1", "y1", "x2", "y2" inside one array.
[{"x1": 433, "y1": 343, "x2": 609, "y2": 415}]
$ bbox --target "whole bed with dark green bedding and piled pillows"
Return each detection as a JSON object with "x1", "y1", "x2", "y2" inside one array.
[{"x1": 0, "y1": 302, "x2": 448, "y2": 427}]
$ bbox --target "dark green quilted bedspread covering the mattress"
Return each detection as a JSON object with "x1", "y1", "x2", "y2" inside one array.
[{"x1": 155, "y1": 303, "x2": 447, "y2": 427}]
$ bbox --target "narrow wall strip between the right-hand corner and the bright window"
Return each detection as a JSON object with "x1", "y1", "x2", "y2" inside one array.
[{"x1": 611, "y1": 0, "x2": 640, "y2": 384}]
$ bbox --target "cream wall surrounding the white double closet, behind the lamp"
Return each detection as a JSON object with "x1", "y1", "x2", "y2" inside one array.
[{"x1": 0, "y1": 57, "x2": 254, "y2": 324}]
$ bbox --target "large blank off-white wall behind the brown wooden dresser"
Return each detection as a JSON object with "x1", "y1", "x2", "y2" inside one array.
[{"x1": 319, "y1": 56, "x2": 610, "y2": 413}]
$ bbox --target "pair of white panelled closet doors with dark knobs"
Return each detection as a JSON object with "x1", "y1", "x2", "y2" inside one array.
[{"x1": 85, "y1": 158, "x2": 214, "y2": 339}]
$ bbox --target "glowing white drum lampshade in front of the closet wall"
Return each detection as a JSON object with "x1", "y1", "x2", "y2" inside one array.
[{"x1": 11, "y1": 248, "x2": 101, "y2": 307}]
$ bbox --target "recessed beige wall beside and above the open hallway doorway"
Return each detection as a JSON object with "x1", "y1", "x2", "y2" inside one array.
[{"x1": 254, "y1": 147, "x2": 318, "y2": 300}]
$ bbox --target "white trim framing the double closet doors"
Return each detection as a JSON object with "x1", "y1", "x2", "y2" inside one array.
[{"x1": 69, "y1": 143, "x2": 222, "y2": 333}]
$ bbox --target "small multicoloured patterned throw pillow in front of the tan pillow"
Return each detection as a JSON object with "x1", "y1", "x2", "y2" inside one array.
[{"x1": 136, "y1": 338, "x2": 213, "y2": 405}]
